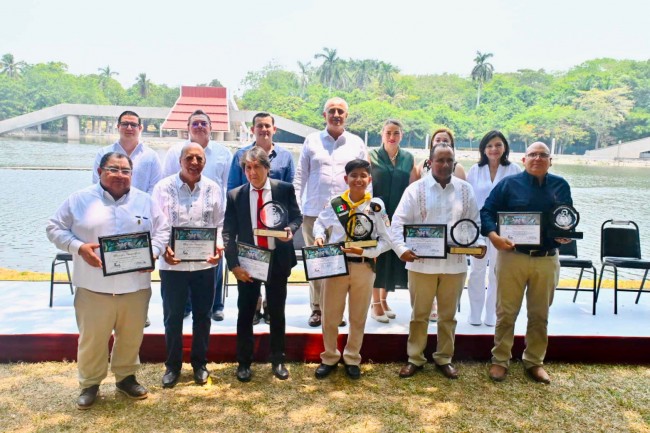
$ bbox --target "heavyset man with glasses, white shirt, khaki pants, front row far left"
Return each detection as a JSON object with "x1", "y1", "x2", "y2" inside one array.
[{"x1": 46, "y1": 152, "x2": 169, "y2": 409}]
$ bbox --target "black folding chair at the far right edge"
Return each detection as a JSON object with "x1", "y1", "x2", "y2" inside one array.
[{"x1": 598, "y1": 220, "x2": 650, "y2": 314}]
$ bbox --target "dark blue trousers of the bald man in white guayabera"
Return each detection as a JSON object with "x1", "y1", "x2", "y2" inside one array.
[{"x1": 160, "y1": 268, "x2": 214, "y2": 371}]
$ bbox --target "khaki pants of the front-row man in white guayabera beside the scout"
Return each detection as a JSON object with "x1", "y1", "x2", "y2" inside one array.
[{"x1": 406, "y1": 271, "x2": 467, "y2": 366}]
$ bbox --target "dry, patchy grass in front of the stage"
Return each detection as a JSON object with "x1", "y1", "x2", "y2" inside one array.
[{"x1": 0, "y1": 362, "x2": 650, "y2": 433}]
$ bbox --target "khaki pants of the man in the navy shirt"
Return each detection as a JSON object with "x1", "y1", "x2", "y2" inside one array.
[{"x1": 492, "y1": 251, "x2": 560, "y2": 368}]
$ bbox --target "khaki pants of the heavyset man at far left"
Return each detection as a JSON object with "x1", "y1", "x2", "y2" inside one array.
[{"x1": 74, "y1": 287, "x2": 151, "y2": 388}]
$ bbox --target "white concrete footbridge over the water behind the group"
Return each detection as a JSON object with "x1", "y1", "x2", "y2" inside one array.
[{"x1": 0, "y1": 104, "x2": 317, "y2": 140}]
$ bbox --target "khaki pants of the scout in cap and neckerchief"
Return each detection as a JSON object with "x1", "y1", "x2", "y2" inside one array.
[{"x1": 320, "y1": 263, "x2": 375, "y2": 365}]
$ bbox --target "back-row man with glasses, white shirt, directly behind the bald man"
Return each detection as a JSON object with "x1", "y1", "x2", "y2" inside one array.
[{"x1": 163, "y1": 110, "x2": 232, "y2": 321}]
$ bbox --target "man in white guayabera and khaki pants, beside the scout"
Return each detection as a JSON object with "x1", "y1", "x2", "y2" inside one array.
[{"x1": 390, "y1": 143, "x2": 485, "y2": 379}]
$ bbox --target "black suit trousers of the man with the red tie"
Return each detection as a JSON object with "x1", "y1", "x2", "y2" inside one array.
[{"x1": 237, "y1": 271, "x2": 288, "y2": 367}]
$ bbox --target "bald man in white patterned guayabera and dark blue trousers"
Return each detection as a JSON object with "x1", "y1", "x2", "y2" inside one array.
[{"x1": 153, "y1": 143, "x2": 225, "y2": 388}]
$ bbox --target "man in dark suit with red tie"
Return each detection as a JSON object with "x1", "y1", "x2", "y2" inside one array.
[{"x1": 223, "y1": 146, "x2": 302, "y2": 382}]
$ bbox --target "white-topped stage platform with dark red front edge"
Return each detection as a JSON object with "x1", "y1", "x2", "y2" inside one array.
[{"x1": 0, "y1": 281, "x2": 650, "y2": 364}]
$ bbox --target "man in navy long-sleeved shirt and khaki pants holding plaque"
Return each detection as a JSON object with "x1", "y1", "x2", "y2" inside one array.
[{"x1": 481, "y1": 142, "x2": 573, "y2": 383}]
